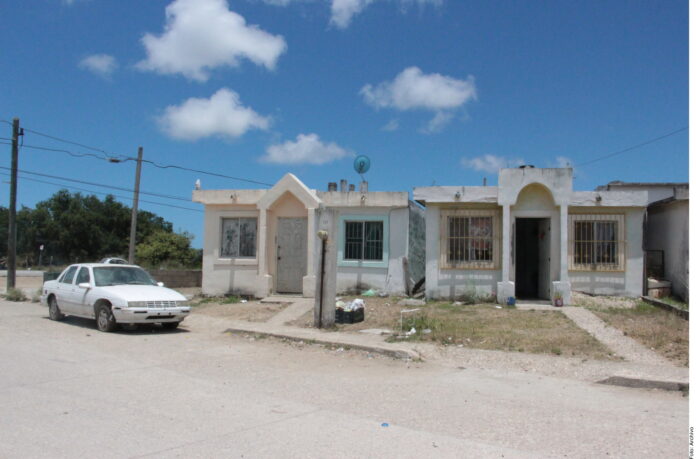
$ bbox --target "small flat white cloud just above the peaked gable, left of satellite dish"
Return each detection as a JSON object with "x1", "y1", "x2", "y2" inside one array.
[{"x1": 261, "y1": 134, "x2": 353, "y2": 165}]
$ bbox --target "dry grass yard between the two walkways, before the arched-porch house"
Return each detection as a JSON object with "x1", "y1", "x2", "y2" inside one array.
[{"x1": 294, "y1": 298, "x2": 613, "y2": 359}]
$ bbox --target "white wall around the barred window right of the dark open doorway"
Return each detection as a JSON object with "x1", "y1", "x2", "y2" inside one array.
[{"x1": 568, "y1": 207, "x2": 645, "y2": 297}]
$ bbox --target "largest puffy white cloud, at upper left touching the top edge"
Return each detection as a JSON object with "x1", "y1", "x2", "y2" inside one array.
[{"x1": 137, "y1": 0, "x2": 287, "y2": 81}]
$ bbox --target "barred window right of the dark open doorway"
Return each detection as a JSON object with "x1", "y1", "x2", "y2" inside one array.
[{"x1": 568, "y1": 215, "x2": 624, "y2": 271}]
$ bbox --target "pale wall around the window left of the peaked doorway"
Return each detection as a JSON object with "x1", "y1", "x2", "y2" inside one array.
[{"x1": 202, "y1": 205, "x2": 259, "y2": 295}]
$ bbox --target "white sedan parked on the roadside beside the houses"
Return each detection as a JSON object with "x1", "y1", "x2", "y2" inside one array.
[{"x1": 41, "y1": 263, "x2": 191, "y2": 332}]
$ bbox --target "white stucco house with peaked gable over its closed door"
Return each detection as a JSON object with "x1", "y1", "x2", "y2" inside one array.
[{"x1": 193, "y1": 174, "x2": 425, "y2": 297}]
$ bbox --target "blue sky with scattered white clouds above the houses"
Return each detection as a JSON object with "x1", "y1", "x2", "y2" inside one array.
[{"x1": 0, "y1": 0, "x2": 688, "y2": 247}]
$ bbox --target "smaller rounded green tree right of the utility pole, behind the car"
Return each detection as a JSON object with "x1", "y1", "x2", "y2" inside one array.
[{"x1": 135, "y1": 230, "x2": 198, "y2": 268}]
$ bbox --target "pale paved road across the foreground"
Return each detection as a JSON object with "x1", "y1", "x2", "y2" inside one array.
[{"x1": 0, "y1": 301, "x2": 688, "y2": 458}]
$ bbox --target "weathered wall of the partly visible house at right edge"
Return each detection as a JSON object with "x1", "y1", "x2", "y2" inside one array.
[{"x1": 646, "y1": 200, "x2": 689, "y2": 300}]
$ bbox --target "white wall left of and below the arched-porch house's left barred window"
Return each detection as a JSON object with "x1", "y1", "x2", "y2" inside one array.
[{"x1": 425, "y1": 205, "x2": 501, "y2": 299}]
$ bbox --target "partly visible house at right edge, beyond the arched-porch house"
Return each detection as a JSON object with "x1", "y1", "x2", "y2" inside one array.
[{"x1": 597, "y1": 181, "x2": 689, "y2": 302}]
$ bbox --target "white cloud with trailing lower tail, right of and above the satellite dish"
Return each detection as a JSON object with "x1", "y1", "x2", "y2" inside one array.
[{"x1": 360, "y1": 67, "x2": 476, "y2": 133}]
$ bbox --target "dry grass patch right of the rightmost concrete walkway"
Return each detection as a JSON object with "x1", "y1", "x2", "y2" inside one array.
[{"x1": 589, "y1": 301, "x2": 689, "y2": 366}]
